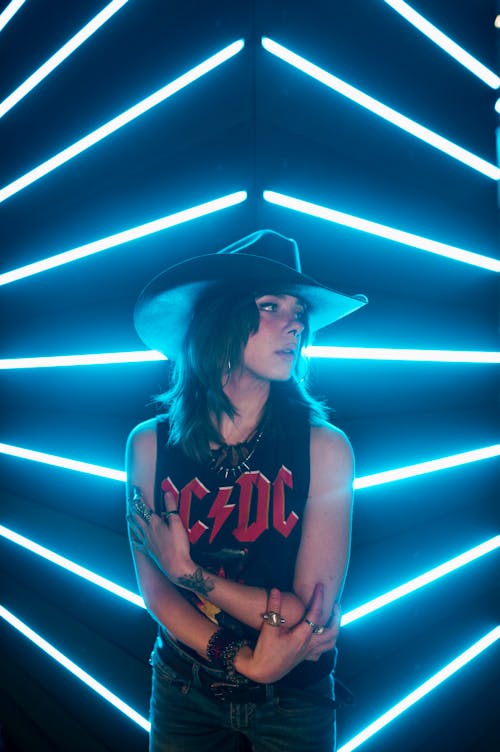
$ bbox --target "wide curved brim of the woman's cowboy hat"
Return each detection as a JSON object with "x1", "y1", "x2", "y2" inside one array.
[{"x1": 134, "y1": 253, "x2": 368, "y2": 359}]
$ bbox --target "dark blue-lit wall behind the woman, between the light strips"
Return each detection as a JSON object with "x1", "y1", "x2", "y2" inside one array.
[{"x1": 0, "y1": 0, "x2": 500, "y2": 752}]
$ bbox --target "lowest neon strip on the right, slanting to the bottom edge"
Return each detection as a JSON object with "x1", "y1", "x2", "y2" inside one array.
[{"x1": 338, "y1": 626, "x2": 500, "y2": 752}]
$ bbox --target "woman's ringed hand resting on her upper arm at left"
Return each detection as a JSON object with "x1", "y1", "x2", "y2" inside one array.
[{"x1": 127, "y1": 492, "x2": 195, "y2": 583}]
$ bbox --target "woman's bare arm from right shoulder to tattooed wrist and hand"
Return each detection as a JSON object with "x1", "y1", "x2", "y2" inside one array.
[{"x1": 131, "y1": 426, "x2": 353, "y2": 629}]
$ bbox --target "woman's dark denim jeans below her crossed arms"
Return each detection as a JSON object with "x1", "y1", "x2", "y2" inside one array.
[{"x1": 149, "y1": 649, "x2": 335, "y2": 752}]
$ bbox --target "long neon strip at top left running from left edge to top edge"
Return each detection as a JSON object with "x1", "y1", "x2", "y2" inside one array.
[{"x1": 0, "y1": 0, "x2": 128, "y2": 118}]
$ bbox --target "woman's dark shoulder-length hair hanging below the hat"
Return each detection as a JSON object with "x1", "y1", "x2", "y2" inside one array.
[{"x1": 155, "y1": 286, "x2": 327, "y2": 462}]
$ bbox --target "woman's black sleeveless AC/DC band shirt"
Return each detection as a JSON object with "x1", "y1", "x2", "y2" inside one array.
[{"x1": 155, "y1": 408, "x2": 334, "y2": 686}]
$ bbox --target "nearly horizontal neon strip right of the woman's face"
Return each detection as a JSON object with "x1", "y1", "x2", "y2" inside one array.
[{"x1": 306, "y1": 345, "x2": 500, "y2": 368}]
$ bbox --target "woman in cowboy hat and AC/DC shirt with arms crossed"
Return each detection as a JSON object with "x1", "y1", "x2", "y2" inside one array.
[{"x1": 127, "y1": 230, "x2": 366, "y2": 752}]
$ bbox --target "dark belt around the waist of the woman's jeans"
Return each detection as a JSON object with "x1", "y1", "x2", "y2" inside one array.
[{"x1": 156, "y1": 640, "x2": 337, "y2": 708}]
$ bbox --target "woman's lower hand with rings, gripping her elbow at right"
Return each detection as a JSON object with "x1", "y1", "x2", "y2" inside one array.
[{"x1": 234, "y1": 585, "x2": 340, "y2": 684}]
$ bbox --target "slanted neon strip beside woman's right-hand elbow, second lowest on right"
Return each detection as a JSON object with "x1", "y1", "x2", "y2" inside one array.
[{"x1": 342, "y1": 535, "x2": 500, "y2": 627}]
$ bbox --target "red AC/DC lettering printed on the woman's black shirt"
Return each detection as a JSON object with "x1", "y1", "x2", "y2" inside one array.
[{"x1": 161, "y1": 465, "x2": 299, "y2": 543}]
